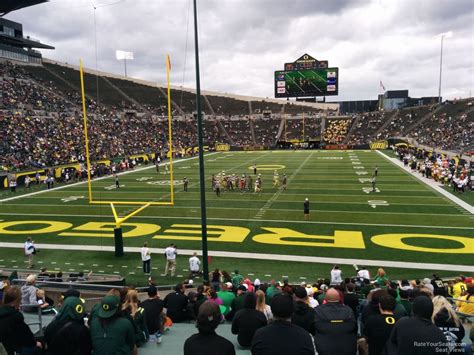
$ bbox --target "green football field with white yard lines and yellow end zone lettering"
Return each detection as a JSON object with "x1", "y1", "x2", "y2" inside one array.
[{"x1": 0, "y1": 151, "x2": 474, "y2": 285}]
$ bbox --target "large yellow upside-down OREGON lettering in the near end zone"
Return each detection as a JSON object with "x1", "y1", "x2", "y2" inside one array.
[{"x1": 0, "y1": 220, "x2": 474, "y2": 254}]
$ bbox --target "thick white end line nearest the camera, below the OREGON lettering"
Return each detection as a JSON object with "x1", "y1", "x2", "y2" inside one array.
[{"x1": 0, "y1": 242, "x2": 474, "y2": 272}]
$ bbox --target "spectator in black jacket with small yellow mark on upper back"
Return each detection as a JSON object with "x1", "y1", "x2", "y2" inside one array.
[{"x1": 315, "y1": 288, "x2": 357, "y2": 355}]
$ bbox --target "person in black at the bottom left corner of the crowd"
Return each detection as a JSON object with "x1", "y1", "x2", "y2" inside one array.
[{"x1": 0, "y1": 286, "x2": 42, "y2": 355}]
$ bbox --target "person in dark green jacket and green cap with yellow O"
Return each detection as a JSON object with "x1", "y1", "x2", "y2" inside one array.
[{"x1": 90, "y1": 296, "x2": 136, "y2": 355}]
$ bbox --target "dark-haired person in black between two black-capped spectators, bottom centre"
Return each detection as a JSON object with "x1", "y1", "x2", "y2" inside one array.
[{"x1": 232, "y1": 293, "x2": 267, "y2": 348}]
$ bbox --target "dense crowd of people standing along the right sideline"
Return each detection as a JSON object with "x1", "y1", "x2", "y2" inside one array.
[{"x1": 394, "y1": 146, "x2": 474, "y2": 194}]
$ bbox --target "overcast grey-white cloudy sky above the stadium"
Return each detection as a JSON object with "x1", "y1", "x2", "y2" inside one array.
[{"x1": 6, "y1": 0, "x2": 474, "y2": 101}]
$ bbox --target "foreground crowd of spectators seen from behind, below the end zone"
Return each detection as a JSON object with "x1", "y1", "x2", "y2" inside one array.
[{"x1": 0, "y1": 265, "x2": 474, "y2": 355}]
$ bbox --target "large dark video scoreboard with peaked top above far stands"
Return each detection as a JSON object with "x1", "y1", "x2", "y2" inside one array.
[{"x1": 275, "y1": 54, "x2": 339, "y2": 98}]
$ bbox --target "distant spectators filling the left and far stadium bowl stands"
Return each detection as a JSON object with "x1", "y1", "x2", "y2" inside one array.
[{"x1": 0, "y1": 62, "x2": 474, "y2": 177}]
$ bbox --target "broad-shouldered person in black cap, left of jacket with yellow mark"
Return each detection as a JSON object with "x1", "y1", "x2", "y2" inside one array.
[{"x1": 251, "y1": 293, "x2": 316, "y2": 355}]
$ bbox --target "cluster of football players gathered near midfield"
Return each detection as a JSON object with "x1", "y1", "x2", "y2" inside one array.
[{"x1": 211, "y1": 166, "x2": 288, "y2": 197}]
